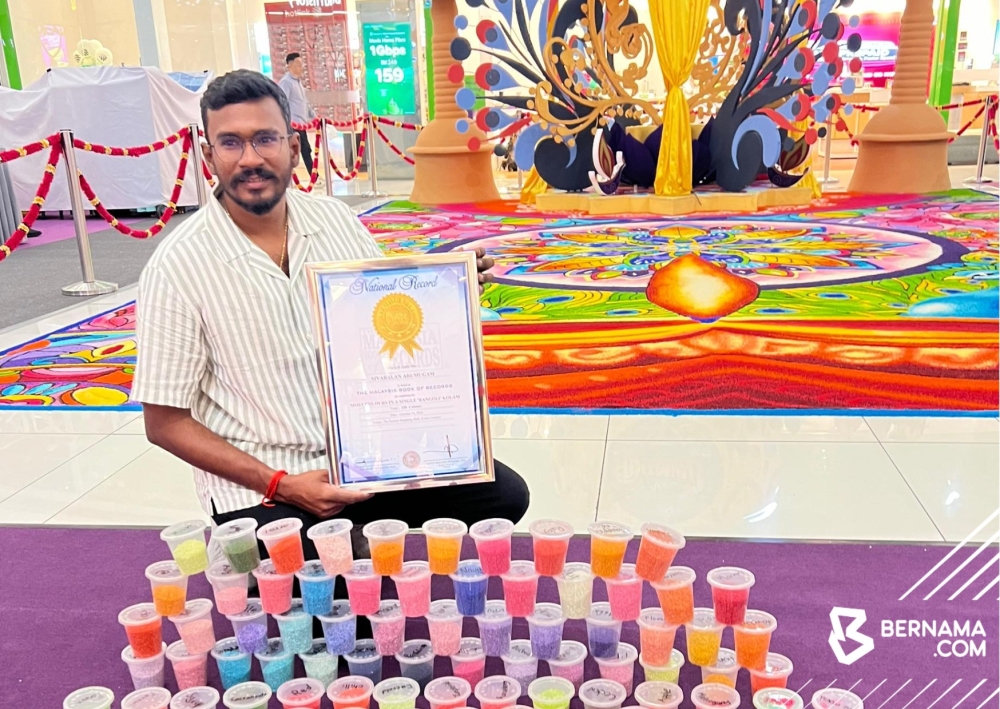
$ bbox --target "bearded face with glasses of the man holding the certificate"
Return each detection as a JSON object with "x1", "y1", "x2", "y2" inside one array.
[{"x1": 202, "y1": 98, "x2": 299, "y2": 214}]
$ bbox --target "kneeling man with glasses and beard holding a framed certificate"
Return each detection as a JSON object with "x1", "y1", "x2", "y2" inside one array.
[{"x1": 132, "y1": 70, "x2": 528, "y2": 553}]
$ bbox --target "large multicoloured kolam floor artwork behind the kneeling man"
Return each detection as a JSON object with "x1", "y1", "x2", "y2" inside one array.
[{"x1": 0, "y1": 190, "x2": 1000, "y2": 413}]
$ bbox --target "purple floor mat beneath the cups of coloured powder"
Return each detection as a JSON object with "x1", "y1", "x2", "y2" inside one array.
[{"x1": 0, "y1": 528, "x2": 1000, "y2": 709}]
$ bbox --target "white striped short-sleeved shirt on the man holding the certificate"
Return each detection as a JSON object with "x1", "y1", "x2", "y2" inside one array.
[{"x1": 132, "y1": 185, "x2": 382, "y2": 514}]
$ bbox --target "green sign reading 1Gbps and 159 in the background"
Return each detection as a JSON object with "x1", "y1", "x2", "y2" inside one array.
[{"x1": 361, "y1": 22, "x2": 417, "y2": 116}]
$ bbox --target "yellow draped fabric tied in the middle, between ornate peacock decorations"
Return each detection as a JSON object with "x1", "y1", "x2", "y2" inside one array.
[{"x1": 649, "y1": 0, "x2": 709, "y2": 196}]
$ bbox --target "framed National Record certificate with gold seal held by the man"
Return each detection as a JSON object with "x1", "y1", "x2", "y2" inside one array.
[{"x1": 306, "y1": 252, "x2": 493, "y2": 492}]
